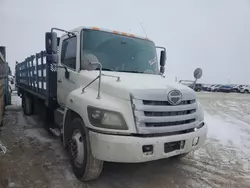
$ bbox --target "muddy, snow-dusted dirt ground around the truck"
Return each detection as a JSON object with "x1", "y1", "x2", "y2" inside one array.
[{"x1": 0, "y1": 93, "x2": 250, "y2": 188}]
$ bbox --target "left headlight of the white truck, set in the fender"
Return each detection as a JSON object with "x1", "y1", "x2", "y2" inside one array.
[{"x1": 88, "y1": 106, "x2": 128, "y2": 130}]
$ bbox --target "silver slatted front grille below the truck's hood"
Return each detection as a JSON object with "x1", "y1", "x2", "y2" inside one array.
[{"x1": 132, "y1": 98, "x2": 198, "y2": 133}]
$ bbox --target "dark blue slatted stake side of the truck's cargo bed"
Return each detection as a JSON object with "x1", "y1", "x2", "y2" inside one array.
[{"x1": 16, "y1": 51, "x2": 57, "y2": 105}]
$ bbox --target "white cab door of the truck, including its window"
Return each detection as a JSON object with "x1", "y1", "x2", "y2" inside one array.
[{"x1": 57, "y1": 36, "x2": 77, "y2": 107}]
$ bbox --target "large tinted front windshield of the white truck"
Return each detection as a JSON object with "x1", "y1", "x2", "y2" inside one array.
[{"x1": 81, "y1": 30, "x2": 159, "y2": 74}]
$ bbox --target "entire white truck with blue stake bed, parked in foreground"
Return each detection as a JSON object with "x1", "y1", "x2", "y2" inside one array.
[{"x1": 16, "y1": 27, "x2": 207, "y2": 181}]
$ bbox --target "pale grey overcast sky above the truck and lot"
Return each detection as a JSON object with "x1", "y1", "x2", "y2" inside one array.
[{"x1": 0, "y1": 0, "x2": 250, "y2": 84}]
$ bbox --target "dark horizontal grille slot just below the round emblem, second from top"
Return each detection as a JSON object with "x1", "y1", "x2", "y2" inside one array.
[{"x1": 144, "y1": 109, "x2": 196, "y2": 117}]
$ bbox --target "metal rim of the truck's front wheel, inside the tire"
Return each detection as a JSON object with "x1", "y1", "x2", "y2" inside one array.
[{"x1": 70, "y1": 130, "x2": 84, "y2": 166}]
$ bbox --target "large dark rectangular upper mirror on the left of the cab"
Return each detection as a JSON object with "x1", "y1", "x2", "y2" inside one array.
[{"x1": 45, "y1": 32, "x2": 58, "y2": 54}]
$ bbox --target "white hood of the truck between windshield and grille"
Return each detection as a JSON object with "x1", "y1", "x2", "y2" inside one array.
[{"x1": 80, "y1": 71, "x2": 196, "y2": 101}]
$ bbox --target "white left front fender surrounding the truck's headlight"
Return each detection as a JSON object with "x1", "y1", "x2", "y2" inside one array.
[{"x1": 63, "y1": 88, "x2": 136, "y2": 142}]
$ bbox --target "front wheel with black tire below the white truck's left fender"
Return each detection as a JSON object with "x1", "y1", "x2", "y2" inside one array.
[{"x1": 66, "y1": 117, "x2": 103, "y2": 182}]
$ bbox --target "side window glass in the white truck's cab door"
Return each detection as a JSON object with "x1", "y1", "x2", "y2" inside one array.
[{"x1": 61, "y1": 37, "x2": 77, "y2": 69}]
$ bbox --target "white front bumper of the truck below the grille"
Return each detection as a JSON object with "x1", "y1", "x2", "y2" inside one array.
[{"x1": 89, "y1": 124, "x2": 207, "y2": 163}]
